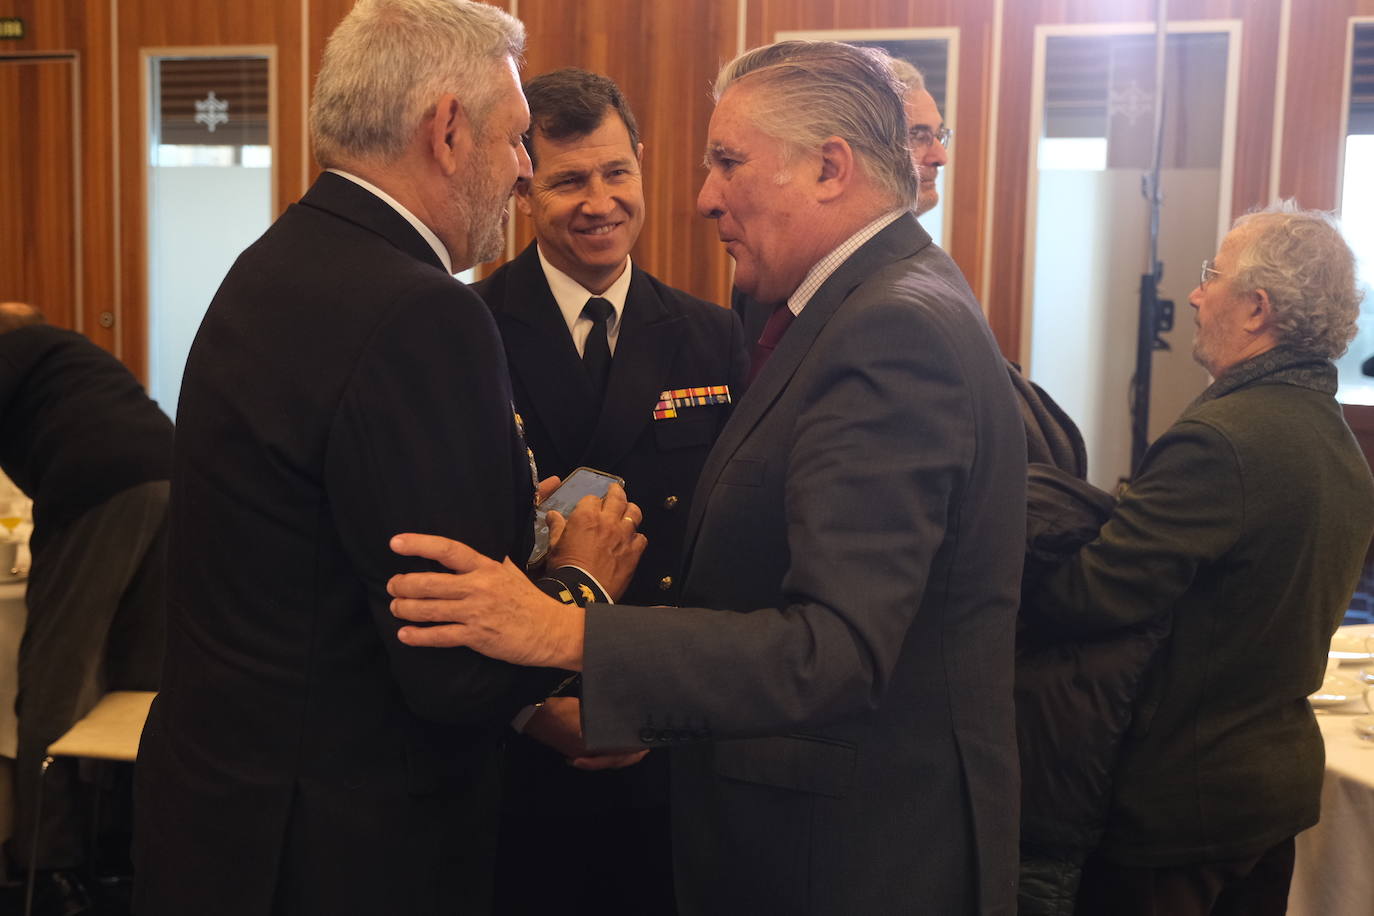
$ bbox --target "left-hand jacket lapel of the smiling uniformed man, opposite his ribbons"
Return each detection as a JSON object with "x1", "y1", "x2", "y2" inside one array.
[{"x1": 497, "y1": 242, "x2": 601, "y2": 467}]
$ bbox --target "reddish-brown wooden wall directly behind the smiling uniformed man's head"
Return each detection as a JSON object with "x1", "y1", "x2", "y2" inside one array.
[{"x1": 494, "y1": 0, "x2": 736, "y2": 304}]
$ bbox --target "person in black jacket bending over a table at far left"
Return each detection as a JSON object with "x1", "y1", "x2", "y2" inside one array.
[{"x1": 0, "y1": 302, "x2": 172, "y2": 912}]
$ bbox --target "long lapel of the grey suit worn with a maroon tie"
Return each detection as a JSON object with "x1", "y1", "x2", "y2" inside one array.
[{"x1": 684, "y1": 213, "x2": 930, "y2": 559}]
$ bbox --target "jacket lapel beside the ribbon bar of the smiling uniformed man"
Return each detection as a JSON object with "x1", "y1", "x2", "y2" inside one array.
[{"x1": 583, "y1": 268, "x2": 684, "y2": 468}]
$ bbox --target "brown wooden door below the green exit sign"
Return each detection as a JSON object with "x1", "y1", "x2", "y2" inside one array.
[{"x1": 0, "y1": 55, "x2": 80, "y2": 328}]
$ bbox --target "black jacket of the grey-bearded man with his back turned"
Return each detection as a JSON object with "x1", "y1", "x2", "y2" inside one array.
[{"x1": 137, "y1": 173, "x2": 556, "y2": 916}]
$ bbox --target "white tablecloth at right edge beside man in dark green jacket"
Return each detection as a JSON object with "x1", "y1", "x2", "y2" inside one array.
[{"x1": 1275, "y1": 623, "x2": 1374, "y2": 916}]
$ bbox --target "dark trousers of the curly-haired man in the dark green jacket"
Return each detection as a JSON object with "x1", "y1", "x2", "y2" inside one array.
[{"x1": 1074, "y1": 836, "x2": 1293, "y2": 916}]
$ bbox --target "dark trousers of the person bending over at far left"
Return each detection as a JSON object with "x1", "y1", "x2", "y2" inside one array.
[{"x1": 8, "y1": 481, "x2": 169, "y2": 869}]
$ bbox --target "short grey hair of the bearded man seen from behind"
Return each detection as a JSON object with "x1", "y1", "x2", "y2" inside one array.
[{"x1": 311, "y1": 0, "x2": 525, "y2": 168}]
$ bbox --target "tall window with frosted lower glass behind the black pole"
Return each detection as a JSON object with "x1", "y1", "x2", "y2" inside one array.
[{"x1": 1028, "y1": 33, "x2": 1228, "y2": 489}]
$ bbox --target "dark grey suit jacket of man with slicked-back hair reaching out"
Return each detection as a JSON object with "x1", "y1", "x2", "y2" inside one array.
[{"x1": 583, "y1": 214, "x2": 1025, "y2": 916}]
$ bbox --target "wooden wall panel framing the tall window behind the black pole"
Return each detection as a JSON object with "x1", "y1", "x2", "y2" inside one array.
[{"x1": 984, "y1": 0, "x2": 1282, "y2": 358}]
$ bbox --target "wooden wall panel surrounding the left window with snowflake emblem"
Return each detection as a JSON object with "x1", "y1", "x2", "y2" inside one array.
[{"x1": 117, "y1": 0, "x2": 305, "y2": 376}]
